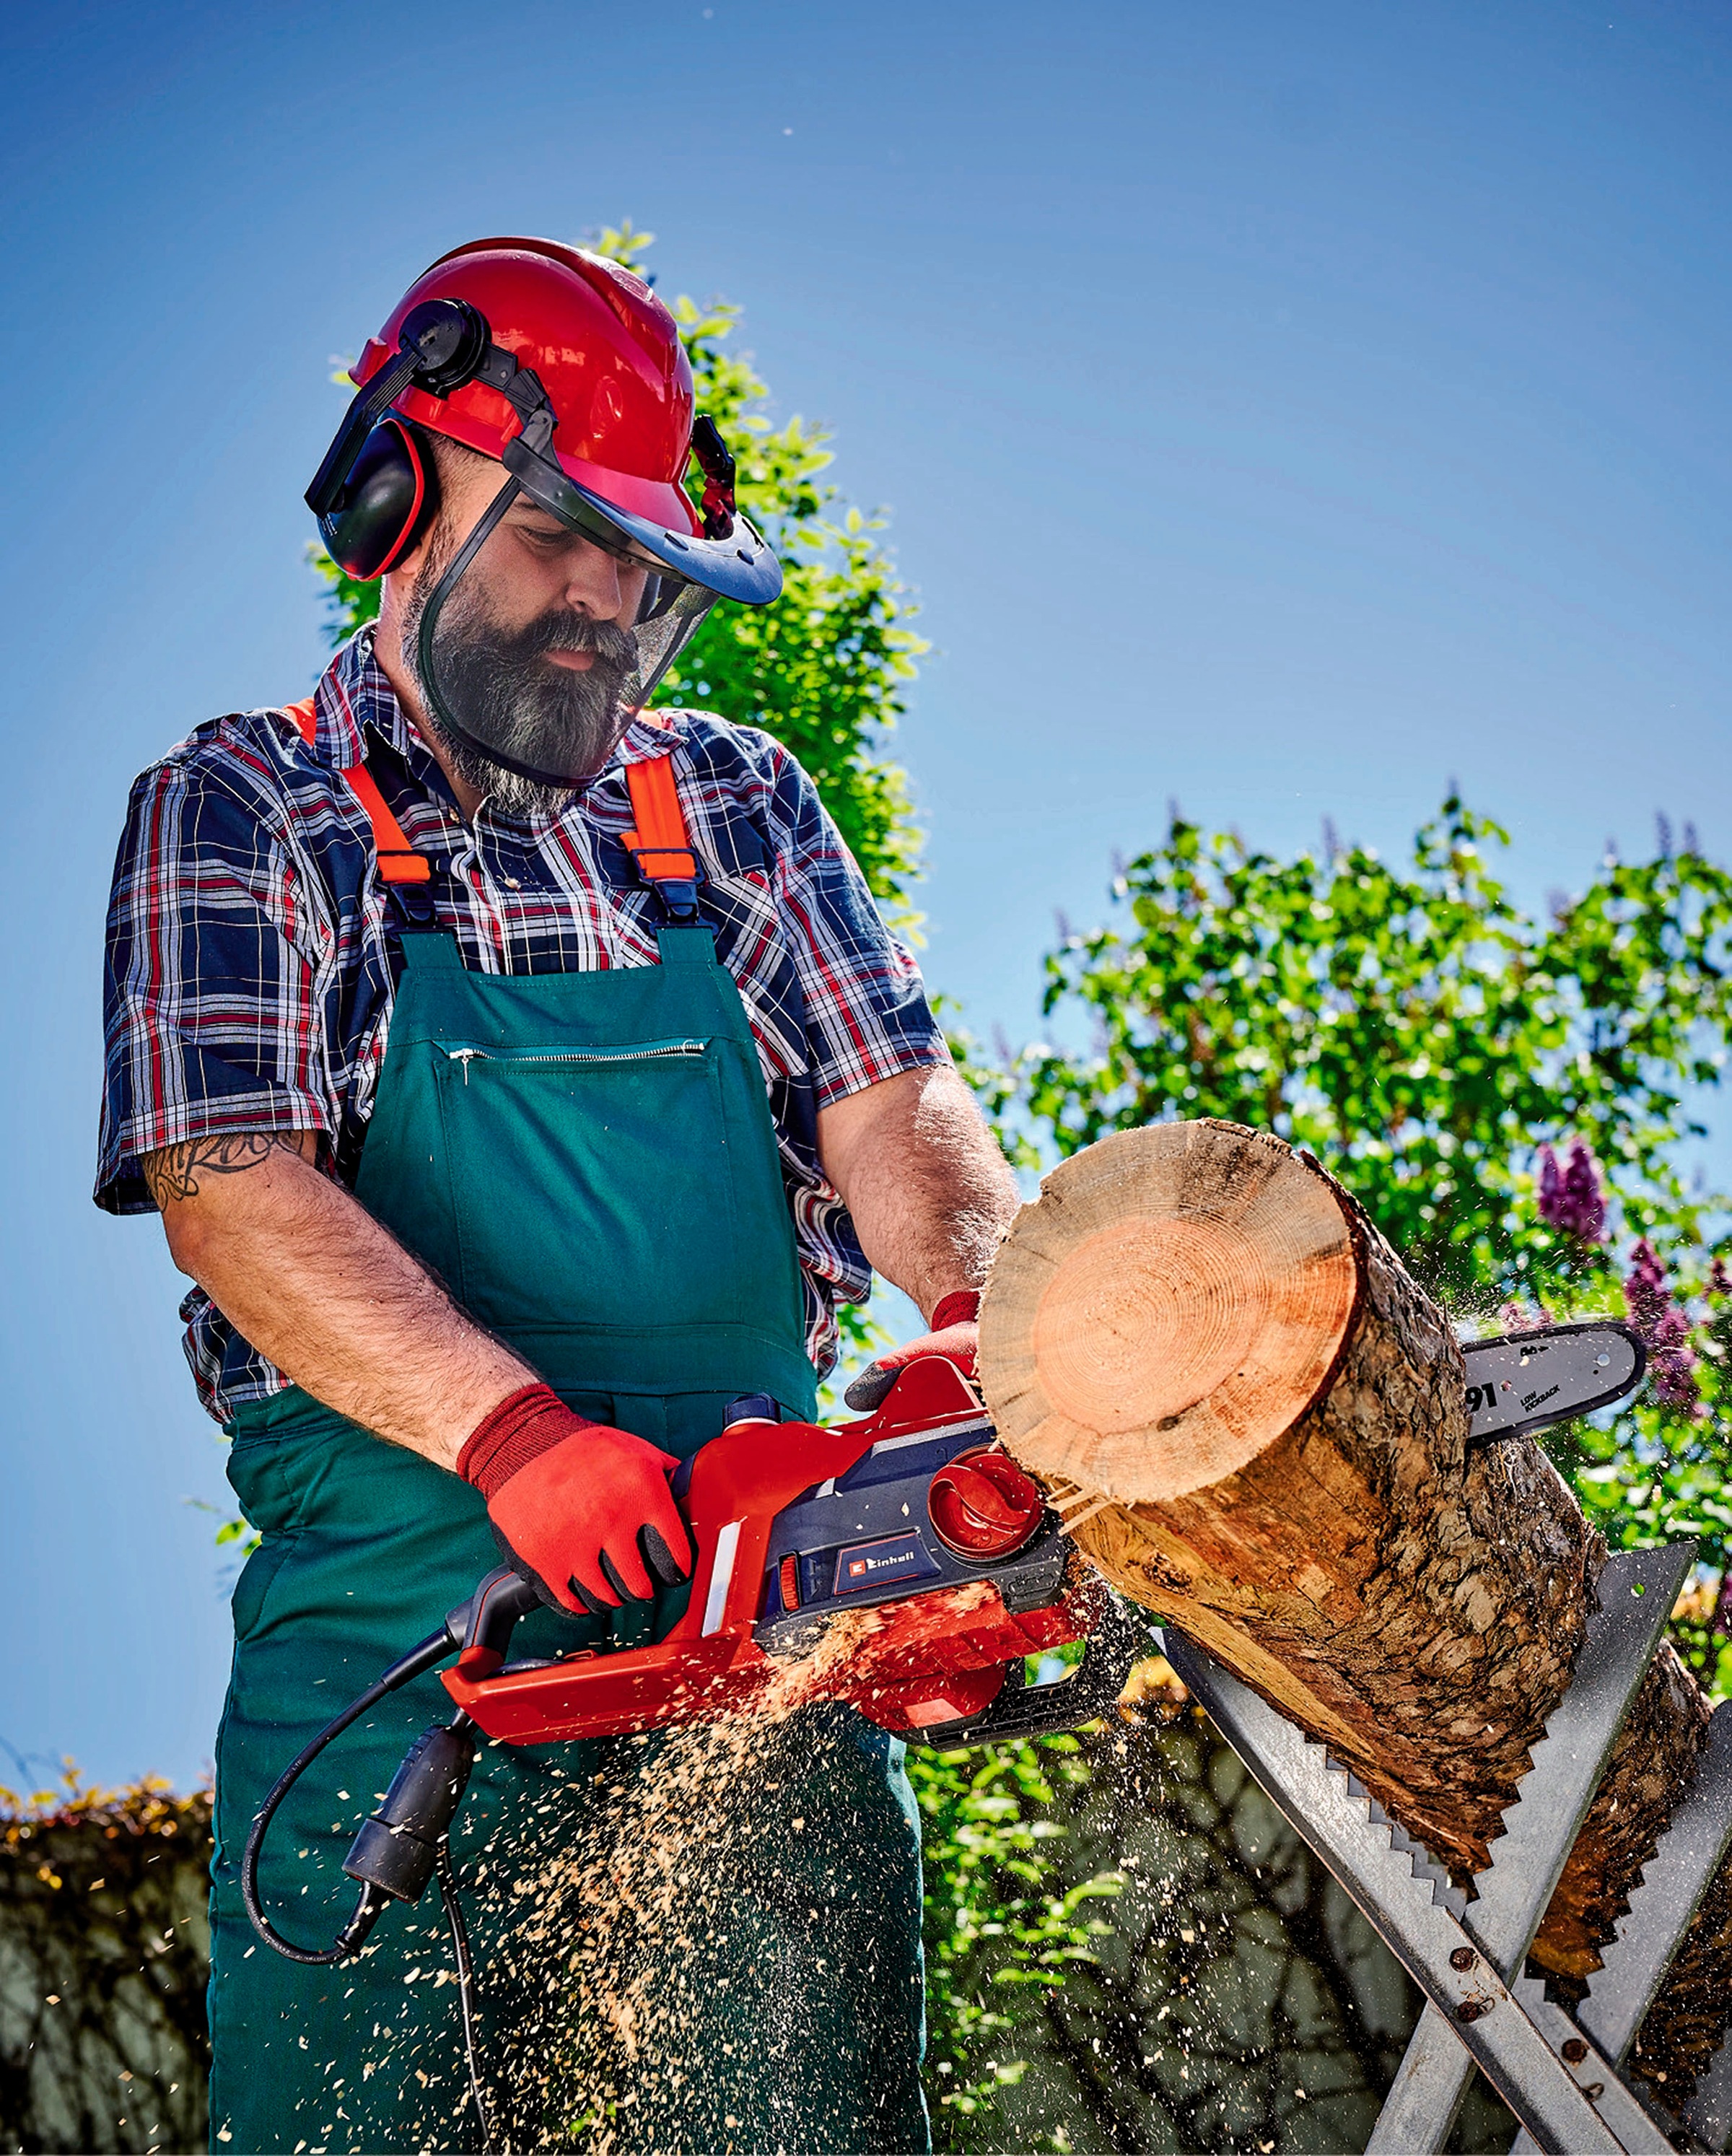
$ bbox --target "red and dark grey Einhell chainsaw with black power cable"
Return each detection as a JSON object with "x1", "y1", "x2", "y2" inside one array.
[{"x1": 242, "y1": 1322, "x2": 1645, "y2": 1975}]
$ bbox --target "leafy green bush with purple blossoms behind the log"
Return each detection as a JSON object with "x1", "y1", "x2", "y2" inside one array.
[{"x1": 962, "y1": 795, "x2": 1732, "y2": 1690}]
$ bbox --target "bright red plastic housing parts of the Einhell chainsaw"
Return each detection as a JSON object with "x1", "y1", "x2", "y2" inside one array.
[{"x1": 445, "y1": 1356, "x2": 1098, "y2": 1744}]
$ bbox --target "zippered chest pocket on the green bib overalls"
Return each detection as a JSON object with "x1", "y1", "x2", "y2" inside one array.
[{"x1": 436, "y1": 1037, "x2": 742, "y2": 1335}]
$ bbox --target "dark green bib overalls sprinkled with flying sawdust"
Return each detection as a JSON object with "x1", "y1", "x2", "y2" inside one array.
[{"x1": 209, "y1": 746, "x2": 927, "y2": 2156}]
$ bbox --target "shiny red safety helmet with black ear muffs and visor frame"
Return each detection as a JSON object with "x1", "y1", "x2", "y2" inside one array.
[{"x1": 306, "y1": 240, "x2": 781, "y2": 782}]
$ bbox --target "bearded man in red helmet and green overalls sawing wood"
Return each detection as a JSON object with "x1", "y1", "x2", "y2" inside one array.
[{"x1": 97, "y1": 240, "x2": 1014, "y2": 2152}]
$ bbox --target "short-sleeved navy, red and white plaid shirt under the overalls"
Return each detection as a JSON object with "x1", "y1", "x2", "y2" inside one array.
[{"x1": 95, "y1": 629, "x2": 945, "y2": 1420}]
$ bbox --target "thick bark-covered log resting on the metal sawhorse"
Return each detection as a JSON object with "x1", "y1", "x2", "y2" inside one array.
[{"x1": 979, "y1": 1121, "x2": 1732, "y2": 2104}]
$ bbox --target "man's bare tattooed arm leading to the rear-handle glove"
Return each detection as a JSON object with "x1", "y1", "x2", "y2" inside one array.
[{"x1": 144, "y1": 1132, "x2": 535, "y2": 1468}]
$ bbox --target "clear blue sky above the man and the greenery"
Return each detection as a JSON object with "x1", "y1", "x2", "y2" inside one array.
[{"x1": 0, "y1": 0, "x2": 1732, "y2": 1781}]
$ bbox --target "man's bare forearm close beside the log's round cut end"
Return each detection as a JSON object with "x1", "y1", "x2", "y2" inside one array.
[{"x1": 818, "y1": 1065, "x2": 1018, "y2": 1317}]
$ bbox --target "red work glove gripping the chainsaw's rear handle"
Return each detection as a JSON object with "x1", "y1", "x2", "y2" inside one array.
[{"x1": 458, "y1": 1384, "x2": 692, "y2": 1617}]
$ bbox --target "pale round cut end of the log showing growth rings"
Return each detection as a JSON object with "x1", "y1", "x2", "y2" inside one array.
[{"x1": 979, "y1": 1121, "x2": 1361, "y2": 1505}]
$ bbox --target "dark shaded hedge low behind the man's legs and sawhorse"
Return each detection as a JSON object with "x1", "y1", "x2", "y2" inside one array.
[{"x1": 0, "y1": 1710, "x2": 1514, "y2": 2156}]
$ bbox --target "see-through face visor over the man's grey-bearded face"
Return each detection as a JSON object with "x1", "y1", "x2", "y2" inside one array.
[{"x1": 414, "y1": 476, "x2": 716, "y2": 789}]
